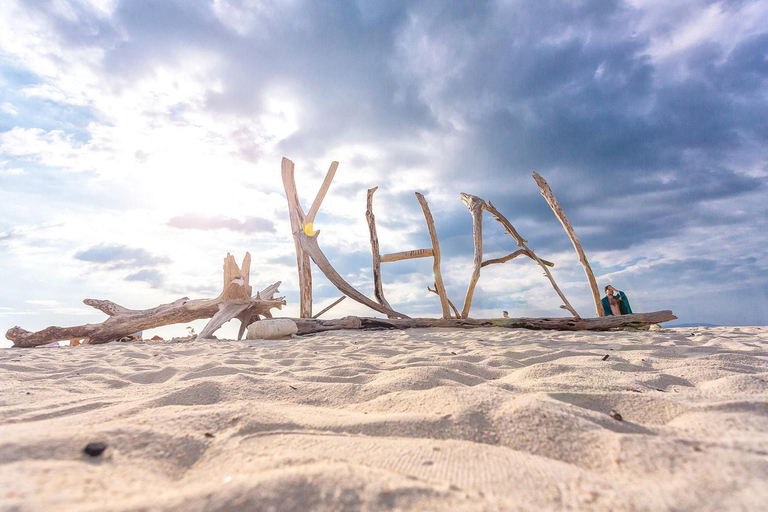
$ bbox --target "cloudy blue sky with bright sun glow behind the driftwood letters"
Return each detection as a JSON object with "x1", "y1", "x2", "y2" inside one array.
[{"x1": 0, "y1": 0, "x2": 768, "y2": 346}]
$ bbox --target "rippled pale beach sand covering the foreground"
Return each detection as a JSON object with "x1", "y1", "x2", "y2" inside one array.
[{"x1": 0, "y1": 327, "x2": 768, "y2": 511}]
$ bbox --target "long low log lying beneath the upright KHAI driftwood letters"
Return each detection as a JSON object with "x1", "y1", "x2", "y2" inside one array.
[{"x1": 293, "y1": 310, "x2": 677, "y2": 335}]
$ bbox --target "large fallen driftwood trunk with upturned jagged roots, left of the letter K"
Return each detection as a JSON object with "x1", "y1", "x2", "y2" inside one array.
[{"x1": 5, "y1": 254, "x2": 285, "y2": 347}]
